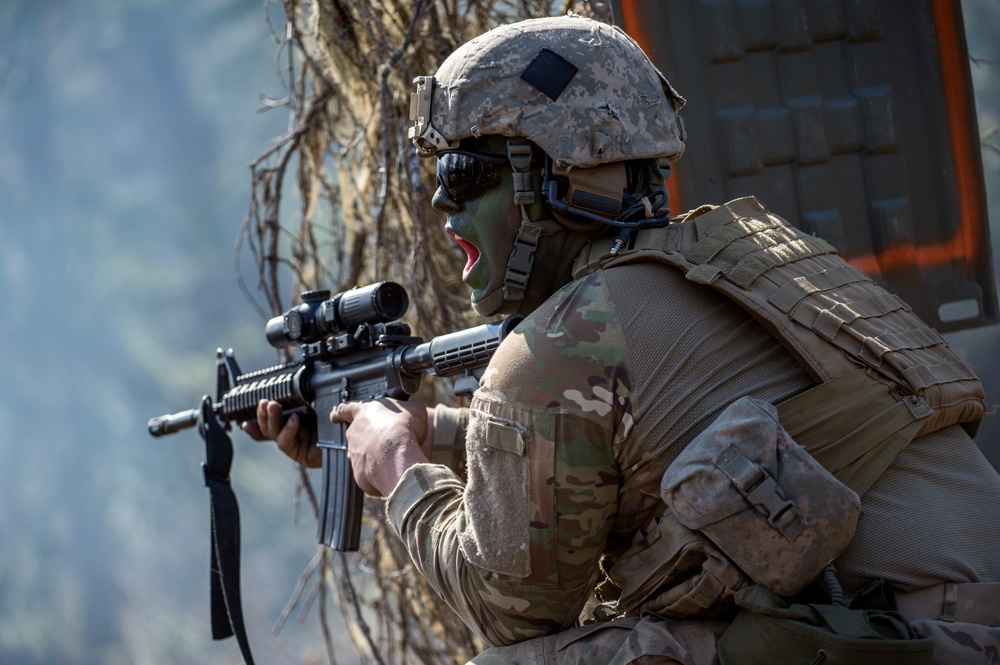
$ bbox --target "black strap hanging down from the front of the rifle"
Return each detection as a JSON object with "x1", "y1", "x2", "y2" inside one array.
[{"x1": 198, "y1": 397, "x2": 254, "y2": 665}]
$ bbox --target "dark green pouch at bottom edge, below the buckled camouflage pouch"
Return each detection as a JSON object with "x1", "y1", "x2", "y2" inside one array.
[{"x1": 716, "y1": 585, "x2": 934, "y2": 665}]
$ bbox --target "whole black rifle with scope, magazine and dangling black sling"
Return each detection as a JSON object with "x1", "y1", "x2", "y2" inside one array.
[{"x1": 149, "y1": 282, "x2": 521, "y2": 665}]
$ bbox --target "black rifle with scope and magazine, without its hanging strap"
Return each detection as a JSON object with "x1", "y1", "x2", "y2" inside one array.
[{"x1": 149, "y1": 282, "x2": 520, "y2": 551}]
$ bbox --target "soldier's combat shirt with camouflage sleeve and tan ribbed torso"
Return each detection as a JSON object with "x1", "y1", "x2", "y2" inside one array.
[{"x1": 387, "y1": 196, "x2": 1000, "y2": 645}]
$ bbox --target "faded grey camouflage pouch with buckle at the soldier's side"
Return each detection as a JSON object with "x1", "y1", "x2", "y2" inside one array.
[{"x1": 661, "y1": 397, "x2": 861, "y2": 597}]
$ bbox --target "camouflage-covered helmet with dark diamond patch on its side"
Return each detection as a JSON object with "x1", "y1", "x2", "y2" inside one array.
[{"x1": 409, "y1": 16, "x2": 684, "y2": 168}]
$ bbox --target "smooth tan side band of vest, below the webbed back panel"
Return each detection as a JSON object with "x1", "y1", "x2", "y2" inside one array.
[{"x1": 777, "y1": 369, "x2": 932, "y2": 496}]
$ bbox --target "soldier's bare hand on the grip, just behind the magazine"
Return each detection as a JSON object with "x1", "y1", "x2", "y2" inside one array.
[{"x1": 330, "y1": 399, "x2": 430, "y2": 496}]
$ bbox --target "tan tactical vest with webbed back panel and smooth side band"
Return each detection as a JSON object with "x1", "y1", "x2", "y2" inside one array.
[{"x1": 573, "y1": 197, "x2": 985, "y2": 494}]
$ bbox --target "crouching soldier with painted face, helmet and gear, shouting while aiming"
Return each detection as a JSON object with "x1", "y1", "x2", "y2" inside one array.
[{"x1": 246, "y1": 17, "x2": 1000, "y2": 665}]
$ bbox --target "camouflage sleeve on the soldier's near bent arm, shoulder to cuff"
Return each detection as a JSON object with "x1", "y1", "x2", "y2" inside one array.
[{"x1": 387, "y1": 277, "x2": 631, "y2": 645}]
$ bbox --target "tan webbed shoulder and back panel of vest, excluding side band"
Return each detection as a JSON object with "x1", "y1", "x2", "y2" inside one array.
[{"x1": 574, "y1": 197, "x2": 985, "y2": 436}]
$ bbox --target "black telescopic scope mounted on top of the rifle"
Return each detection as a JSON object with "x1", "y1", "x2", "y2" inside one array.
[{"x1": 264, "y1": 282, "x2": 410, "y2": 348}]
